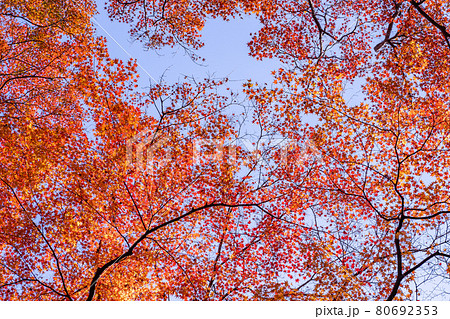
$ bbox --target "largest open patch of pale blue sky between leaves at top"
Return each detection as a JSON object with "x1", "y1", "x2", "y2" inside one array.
[{"x1": 94, "y1": 1, "x2": 279, "y2": 88}]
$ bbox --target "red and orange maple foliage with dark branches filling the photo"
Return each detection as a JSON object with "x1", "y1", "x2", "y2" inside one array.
[{"x1": 0, "y1": 0, "x2": 450, "y2": 300}]
